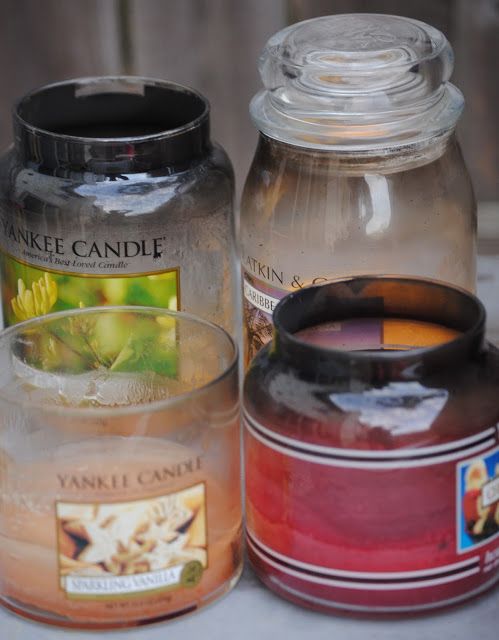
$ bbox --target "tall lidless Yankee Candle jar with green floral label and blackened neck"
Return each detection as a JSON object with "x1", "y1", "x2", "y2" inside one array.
[{"x1": 0, "y1": 77, "x2": 234, "y2": 331}]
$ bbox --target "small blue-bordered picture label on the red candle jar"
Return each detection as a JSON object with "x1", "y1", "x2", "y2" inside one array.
[{"x1": 457, "y1": 448, "x2": 499, "y2": 553}]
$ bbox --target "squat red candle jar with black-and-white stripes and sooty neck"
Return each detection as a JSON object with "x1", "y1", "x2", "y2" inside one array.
[{"x1": 244, "y1": 277, "x2": 499, "y2": 614}]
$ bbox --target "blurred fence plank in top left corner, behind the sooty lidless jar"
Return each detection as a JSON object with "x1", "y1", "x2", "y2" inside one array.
[{"x1": 0, "y1": 0, "x2": 121, "y2": 148}]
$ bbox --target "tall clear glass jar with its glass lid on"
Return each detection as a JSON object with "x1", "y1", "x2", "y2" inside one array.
[{"x1": 240, "y1": 14, "x2": 476, "y2": 363}]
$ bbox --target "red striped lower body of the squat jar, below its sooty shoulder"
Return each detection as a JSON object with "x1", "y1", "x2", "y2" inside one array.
[{"x1": 244, "y1": 408, "x2": 499, "y2": 606}]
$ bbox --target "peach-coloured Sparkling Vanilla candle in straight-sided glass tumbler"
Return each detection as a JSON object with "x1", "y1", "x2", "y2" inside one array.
[{"x1": 0, "y1": 307, "x2": 242, "y2": 629}]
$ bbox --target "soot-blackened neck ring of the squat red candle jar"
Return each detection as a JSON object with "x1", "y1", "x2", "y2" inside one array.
[{"x1": 271, "y1": 276, "x2": 485, "y2": 382}]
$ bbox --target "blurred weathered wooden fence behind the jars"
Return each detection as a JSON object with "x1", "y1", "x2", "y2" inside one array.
[{"x1": 0, "y1": 0, "x2": 499, "y2": 200}]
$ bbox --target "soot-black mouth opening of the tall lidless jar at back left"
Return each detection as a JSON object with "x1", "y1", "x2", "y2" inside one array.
[{"x1": 14, "y1": 76, "x2": 209, "y2": 144}]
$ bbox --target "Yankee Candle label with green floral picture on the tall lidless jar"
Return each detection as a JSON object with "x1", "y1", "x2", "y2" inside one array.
[{"x1": 0, "y1": 210, "x2": 180, "y2": 325}]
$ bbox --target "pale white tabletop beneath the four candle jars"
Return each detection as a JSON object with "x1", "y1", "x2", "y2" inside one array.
[{"x1": 0, "y1": 209, "x2": 499, "y2": 640}]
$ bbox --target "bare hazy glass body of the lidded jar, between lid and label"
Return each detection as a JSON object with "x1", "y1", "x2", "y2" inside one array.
[{"x1": 240, "y1": 138, "x2": 476, "y2": 290}]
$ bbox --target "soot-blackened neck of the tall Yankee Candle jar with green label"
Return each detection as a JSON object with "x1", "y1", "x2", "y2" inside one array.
[{"x1": 14, "y1": 77, "x2": 211, "y2": 174}]
